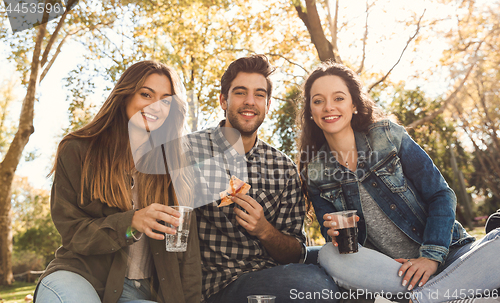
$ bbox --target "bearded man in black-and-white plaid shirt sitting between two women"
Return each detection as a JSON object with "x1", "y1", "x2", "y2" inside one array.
[{"x1": 189, "y1": 55, "x2": 338, "y2": 303}]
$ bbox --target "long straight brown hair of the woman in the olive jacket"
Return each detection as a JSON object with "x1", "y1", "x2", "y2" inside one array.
[{"x1": 51, "y1": 61, "x2": 193, "y2": 211}]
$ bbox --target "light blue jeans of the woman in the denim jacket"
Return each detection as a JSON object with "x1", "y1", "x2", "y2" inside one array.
[{"x1": 319, "y1": 228, "x2": 500, "y2": 303}]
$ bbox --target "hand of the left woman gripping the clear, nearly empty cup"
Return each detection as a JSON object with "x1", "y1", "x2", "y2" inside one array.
[{"x1": 132, "y1": 203, "x2": 180, "y2": 240}]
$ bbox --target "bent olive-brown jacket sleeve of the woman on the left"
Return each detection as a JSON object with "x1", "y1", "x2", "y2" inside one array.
[{"x1": 51, "y1": 140, "x2": 134, "y2": 255}]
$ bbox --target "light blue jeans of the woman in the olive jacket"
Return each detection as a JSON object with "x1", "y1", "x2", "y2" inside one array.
[{"x1": 35, "y1": 270, "x2": 154, "y2": 303}]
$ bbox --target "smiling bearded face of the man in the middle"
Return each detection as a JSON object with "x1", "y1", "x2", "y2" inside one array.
[{"x1": 220, "y1": 72, "x2": 269, "y2": 137}]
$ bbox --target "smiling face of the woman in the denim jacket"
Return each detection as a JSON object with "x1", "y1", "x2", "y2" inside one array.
[{"x1": 310, "y1": 75, "x2": 356, "y2": 137}]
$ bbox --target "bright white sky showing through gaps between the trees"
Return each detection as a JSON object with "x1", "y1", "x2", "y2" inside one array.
[{"x1": 0, "y1": 0, "x2": 458, "y2": 189}]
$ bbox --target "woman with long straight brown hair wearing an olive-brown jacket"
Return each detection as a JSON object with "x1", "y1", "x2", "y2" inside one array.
[{"x1": 35, "y1": 61, "x2": 201, "y2": 303}]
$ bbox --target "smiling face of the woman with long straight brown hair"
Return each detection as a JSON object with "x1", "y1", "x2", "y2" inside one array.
[{"x1": 126, "y1": 74, "x2": 172, "y2": 131}]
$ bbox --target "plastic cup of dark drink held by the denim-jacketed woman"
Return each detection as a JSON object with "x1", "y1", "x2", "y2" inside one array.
[{"x1": 330, "y1": 210, "x2": 358, "y2": 254}]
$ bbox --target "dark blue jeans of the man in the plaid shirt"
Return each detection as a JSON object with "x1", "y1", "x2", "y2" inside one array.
[{"x1": 207, "y1": 263, "x2": 339, "y2": 303}]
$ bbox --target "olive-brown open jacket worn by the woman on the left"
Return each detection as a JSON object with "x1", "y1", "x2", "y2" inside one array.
[{"x1": 40, "y1": 140, "x2": 201, "y2": 303}]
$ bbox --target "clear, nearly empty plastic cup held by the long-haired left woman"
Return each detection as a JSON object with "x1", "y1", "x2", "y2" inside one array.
[{"x1": 165, "y1": 206, "x2": 193, "y2": 252}]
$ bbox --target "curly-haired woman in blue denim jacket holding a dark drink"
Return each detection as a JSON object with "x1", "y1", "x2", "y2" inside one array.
[{"x1": 300, "y1": 63, "x2": 500, "y2": 302}]
